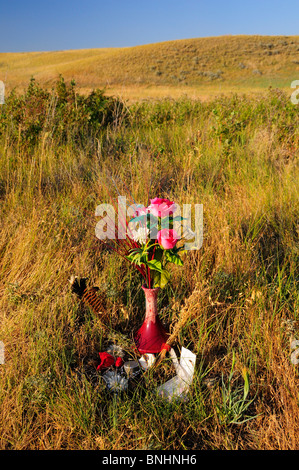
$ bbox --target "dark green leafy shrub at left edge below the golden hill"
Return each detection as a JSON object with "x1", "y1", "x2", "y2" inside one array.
[{"x1": 0, "y1": 77, "x2": 126, "y2": 148}]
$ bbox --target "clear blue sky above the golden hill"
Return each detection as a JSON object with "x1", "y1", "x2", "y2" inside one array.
[{"x1": 0, "y1": 0, "x2": 299, "y2": 52}]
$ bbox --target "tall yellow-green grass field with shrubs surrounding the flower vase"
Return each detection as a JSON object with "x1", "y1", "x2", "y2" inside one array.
[{"x1": 0, "y1": 81, "x2": 299, "y2": 452}]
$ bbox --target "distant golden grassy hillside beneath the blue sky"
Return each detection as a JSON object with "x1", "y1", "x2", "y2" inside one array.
[{"x1": 0, "y1": 36, "x2": 299, "y2": 99}]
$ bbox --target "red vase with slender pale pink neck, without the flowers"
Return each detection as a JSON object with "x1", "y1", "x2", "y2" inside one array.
[{"x1": 134, "y1": 286, "x2": 168, "y2": 354}]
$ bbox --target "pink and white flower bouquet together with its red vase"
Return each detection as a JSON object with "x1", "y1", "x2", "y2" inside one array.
[{"x1": 97, "y1": 197, "x2": 190, "y2": 354}]
